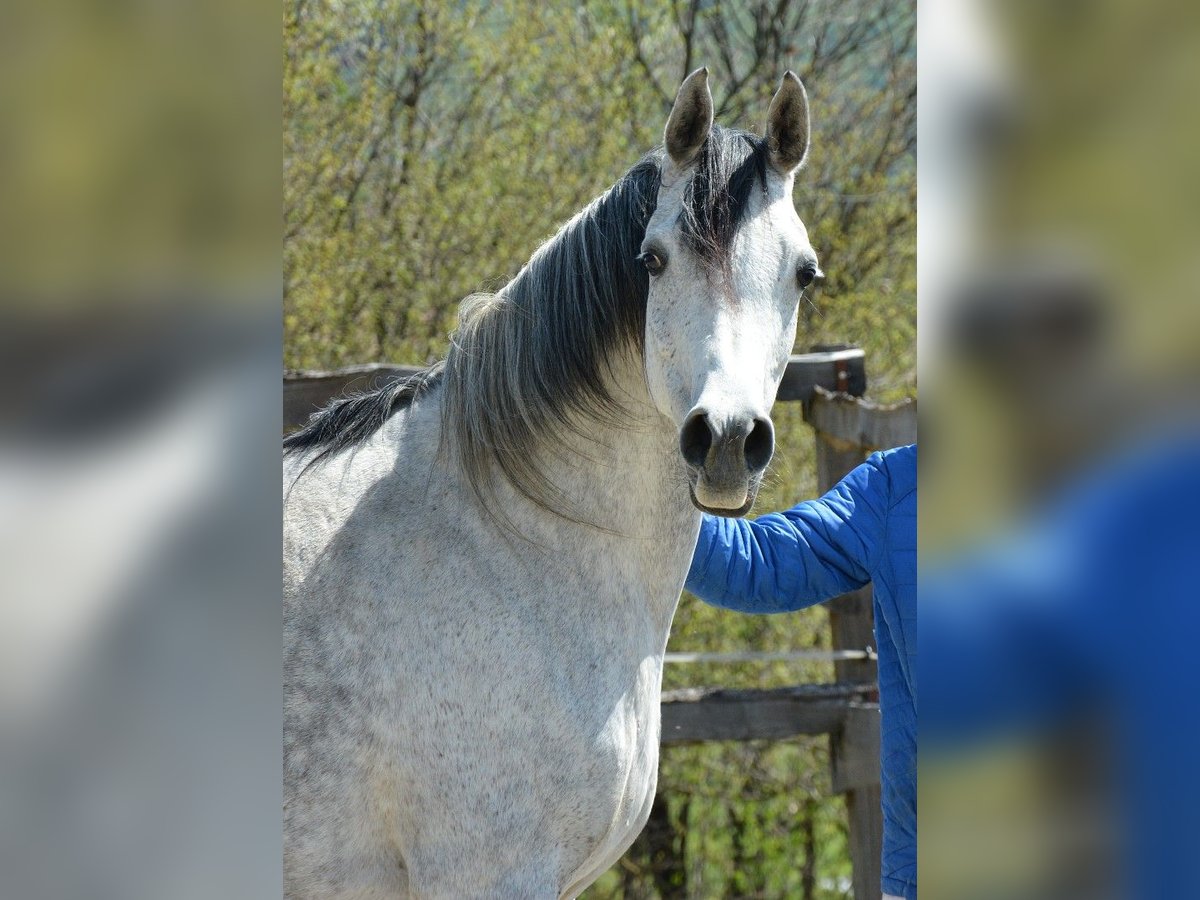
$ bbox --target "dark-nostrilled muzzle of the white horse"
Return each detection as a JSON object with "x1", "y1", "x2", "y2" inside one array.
[{"x1": 679, "y1": 409, "x2": 775, "y2": 516}]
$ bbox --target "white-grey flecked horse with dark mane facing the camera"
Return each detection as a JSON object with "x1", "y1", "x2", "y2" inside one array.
[{"x1": 283, "y1": 70, "x2": 817, "y2": 900}]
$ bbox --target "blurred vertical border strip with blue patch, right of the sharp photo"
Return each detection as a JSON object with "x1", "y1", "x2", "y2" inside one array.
[{"x1": 919, "y1": 0, "x2": 1200, "y2": 900}]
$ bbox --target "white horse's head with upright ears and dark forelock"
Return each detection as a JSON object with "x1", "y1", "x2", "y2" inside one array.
[{"x1": 640, "y1": 68, "x2": 820, "y2": 516}]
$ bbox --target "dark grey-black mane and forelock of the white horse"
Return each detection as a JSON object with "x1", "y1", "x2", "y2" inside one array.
[{"x1": 283, "y1": 125, "x2": 767, "y2": 496}]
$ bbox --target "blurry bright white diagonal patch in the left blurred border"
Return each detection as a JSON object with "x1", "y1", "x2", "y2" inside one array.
[{"x1": 0, "y1": 367, "x2": 230, "y2": 727}]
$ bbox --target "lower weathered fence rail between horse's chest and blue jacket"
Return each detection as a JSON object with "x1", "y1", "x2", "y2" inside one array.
[{"x1": 662, "y1": 684, "x2": 868, "y2": 744}]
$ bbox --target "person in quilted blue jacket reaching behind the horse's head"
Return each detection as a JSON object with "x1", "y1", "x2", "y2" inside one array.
[{"x1": 686, "y1": 444, "x2": 917, "y2": 900}]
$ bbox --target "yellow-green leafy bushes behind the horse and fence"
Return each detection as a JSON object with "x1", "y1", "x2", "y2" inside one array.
[{"x1": 283, "y1": 0, "x2": 916, "y2": 898}]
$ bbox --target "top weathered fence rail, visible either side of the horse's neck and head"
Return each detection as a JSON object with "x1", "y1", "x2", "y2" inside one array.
[{"x1": 283, "y1": 347, "x2": 866, "y2": 431}]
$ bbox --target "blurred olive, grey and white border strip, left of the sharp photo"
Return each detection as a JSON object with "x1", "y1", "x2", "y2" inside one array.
[{"x1": 0, "y1": 0, "x2": 282, "y2": 900}]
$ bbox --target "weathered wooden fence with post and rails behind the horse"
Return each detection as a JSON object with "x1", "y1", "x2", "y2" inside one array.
[{"x1": 283, "y1": 346, "x2": 917, "y2": 900}]
